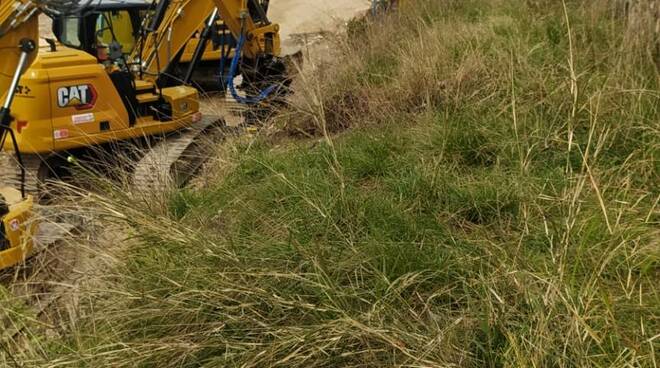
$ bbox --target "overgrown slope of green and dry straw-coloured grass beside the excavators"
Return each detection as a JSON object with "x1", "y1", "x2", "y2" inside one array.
[{"x1": 16, "y1": 0, "x2": 660, "y2": 367}]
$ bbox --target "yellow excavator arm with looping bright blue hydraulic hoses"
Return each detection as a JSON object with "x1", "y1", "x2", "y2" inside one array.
[{"x1": 137, "y1": 0, "x2": 288, "y2": 95}]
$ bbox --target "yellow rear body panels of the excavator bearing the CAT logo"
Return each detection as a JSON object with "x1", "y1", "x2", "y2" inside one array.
[{"x1": 4, "y1": 47, "x2": 200, "y2": 154}]
